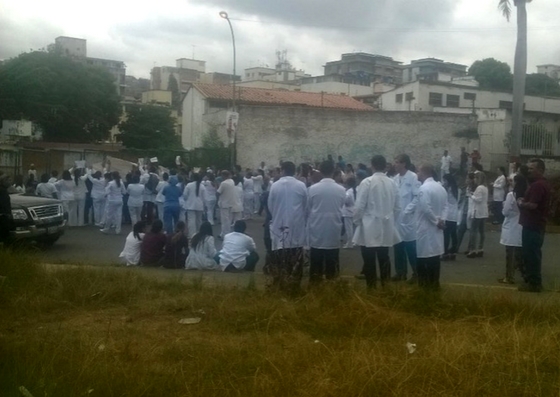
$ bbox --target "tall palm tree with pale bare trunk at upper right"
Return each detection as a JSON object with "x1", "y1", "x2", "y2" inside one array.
[{"x1": 498, "y1": 0, "x2": 532, "y2": 158}]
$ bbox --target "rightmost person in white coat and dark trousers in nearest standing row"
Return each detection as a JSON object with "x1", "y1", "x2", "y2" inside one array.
[{"x1": 405, "y1": 164, "x2": 447, "y2": 290}]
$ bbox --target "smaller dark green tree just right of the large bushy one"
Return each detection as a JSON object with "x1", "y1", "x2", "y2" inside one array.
[{"x1": 118, "y1": 105, "x2": 181, "y2": 150}]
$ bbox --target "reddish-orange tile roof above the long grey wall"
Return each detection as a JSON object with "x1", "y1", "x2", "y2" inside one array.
[{"x1": 193, "y1": 84, "x2": 373, "y2": 111}]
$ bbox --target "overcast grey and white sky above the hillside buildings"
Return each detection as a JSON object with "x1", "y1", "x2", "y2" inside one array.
[{"x1": 0, "y1": 0, "x2": 560, "y2": 78}]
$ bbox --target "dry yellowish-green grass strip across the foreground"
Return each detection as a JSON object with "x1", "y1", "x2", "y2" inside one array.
[{"x1": 0, "y1": 252, "x2": 560, "y2": 397}]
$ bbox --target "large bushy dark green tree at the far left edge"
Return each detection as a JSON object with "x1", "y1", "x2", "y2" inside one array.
[{"x1": 0, "y1": 51, "x2": 120, "y2": 142}]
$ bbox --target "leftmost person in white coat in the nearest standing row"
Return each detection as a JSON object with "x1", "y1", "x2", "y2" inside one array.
[{"x1": 267, "y1": 161, "x2": 307, "y2": 292}]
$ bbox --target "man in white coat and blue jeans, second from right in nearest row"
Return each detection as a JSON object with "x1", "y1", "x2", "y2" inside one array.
[{"x1": 391, "y1": 154, "x2": 420, "y2": 283}]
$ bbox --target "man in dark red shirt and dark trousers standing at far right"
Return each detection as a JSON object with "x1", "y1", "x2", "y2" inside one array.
[{"x1": 517, "y1": 159, "x2": 550, "y2": 292}]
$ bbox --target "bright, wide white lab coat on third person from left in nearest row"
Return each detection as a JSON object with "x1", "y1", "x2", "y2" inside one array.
[{"x1": 352, "y1": 172, "x2": 401, "y2": 247}]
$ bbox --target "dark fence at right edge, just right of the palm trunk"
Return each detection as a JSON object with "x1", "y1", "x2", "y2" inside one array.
[{"x1": 521, "y1": 124, "x2": 560, "y2": 157}]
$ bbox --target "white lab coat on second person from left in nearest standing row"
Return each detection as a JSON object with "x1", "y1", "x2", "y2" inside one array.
[{"x1": 307, "y1": 178, "x2": 346, "y2": 249}]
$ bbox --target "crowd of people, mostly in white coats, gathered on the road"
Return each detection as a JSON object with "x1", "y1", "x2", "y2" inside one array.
[{"x1": 0, "y1": 152, "x2": 550, "y2": 291}]
